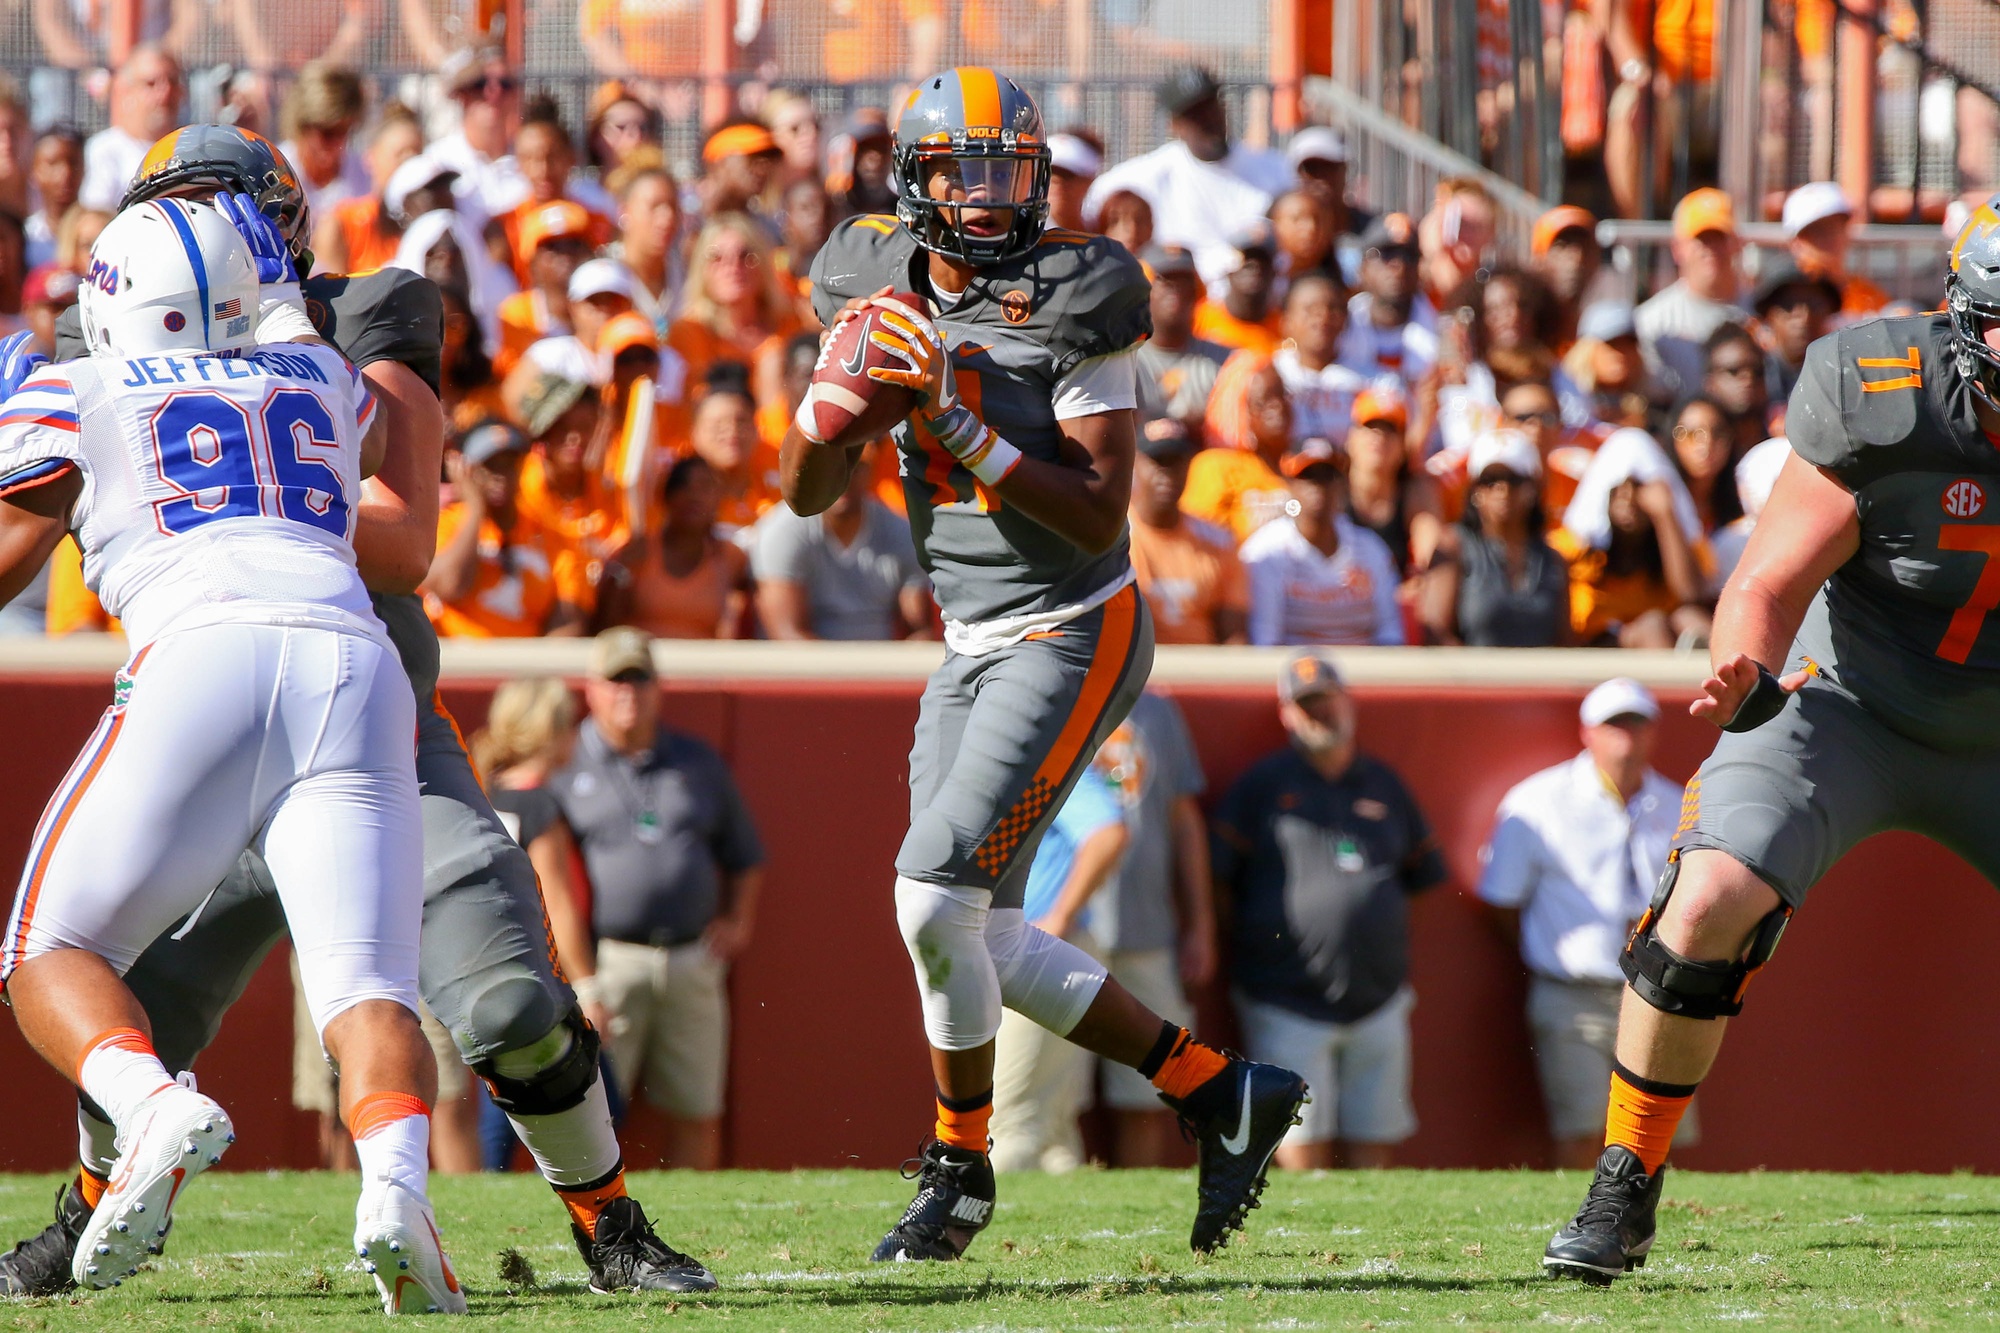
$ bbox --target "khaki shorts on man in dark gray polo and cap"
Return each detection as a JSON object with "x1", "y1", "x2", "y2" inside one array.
[{"x1": 598, "y1": 939, "x2": 730, "y2": 1121}]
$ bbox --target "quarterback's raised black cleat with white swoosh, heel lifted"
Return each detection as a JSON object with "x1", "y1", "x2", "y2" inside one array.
[{"x1": 1160, "y1": 1057, "x2": 1312, "y2": 1253}]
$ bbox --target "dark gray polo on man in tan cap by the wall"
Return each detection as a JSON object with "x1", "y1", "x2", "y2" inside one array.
[{"x1": 548, "y1": 719, "x2": 764, "y2": 947}]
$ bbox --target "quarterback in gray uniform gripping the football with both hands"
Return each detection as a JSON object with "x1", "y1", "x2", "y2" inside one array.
[{"x1": 784, "y1": 68, "x2": 1306, "y2": 1259}]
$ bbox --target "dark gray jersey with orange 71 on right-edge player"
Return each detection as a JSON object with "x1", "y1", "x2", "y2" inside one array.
[{"x1": 1786, "y1": 314, "x2": 2000, "y2": 751}]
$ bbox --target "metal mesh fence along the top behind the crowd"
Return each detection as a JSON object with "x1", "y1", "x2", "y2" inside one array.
[{"x1": 0, "y1": 0, "x2": 1274, "y2": 176}]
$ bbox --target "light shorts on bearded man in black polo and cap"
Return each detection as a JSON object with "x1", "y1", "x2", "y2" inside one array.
[{"x1": 1236, "y1": 987, "x2": 1416, "y2": 1147}]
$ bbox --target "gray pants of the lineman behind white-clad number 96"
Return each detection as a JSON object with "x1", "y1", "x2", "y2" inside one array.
[{"x1": 114, "y1": 680, "x2": 576, "y2": 1071}]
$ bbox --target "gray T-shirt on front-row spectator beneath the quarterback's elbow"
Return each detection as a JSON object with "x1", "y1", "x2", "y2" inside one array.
[{"x1": 750, "y1": 500, "x2": 928, "y2": 638}]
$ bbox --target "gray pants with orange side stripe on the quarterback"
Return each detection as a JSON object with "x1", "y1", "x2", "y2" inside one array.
[{"x1": 896, "y1": 584, "x2": 1152, "y2": 909}]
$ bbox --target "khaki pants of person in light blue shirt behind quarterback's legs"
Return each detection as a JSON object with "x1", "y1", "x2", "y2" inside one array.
[{"x1": 988, "y1": 931, "x2": 1104, "y2": 1175}]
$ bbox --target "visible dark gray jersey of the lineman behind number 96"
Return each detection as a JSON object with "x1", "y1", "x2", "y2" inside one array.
[{"x1": 56, "y1": 268, "x2": 444, "y2": 709}]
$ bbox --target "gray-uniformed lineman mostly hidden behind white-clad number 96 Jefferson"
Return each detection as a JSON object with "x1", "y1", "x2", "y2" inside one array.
[{"x1": 0, "y1": 126, "x2": 716, "y2": 1295}]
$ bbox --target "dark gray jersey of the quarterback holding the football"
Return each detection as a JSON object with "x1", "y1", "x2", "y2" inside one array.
[{"x1": 812, "y1": 214, "x2": 1152, "y2": 620}]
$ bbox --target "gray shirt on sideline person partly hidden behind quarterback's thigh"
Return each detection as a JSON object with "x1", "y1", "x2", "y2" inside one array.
[{"x1": 1094, "y1": 691, "x2": 1208, "y2": 951}]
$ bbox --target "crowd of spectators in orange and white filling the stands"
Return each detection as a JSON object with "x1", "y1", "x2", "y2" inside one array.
[{"x1": 0, "y1": 35, "x2": 1886, "y2": 646}]
